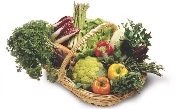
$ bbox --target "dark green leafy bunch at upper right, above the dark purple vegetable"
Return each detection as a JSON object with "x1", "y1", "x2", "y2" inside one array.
[{"x1": 120, "y1": 19, "x2": 152, "y2": 56}]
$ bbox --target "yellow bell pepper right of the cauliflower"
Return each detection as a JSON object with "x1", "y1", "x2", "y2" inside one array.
[{"x1": 108, "y1": 63, "x2": 128, "y2": 80}]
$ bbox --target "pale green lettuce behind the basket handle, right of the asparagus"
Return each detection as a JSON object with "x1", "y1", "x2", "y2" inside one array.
[{"x1": 74, "y1": 18, "x2": 113, "y2": 62}]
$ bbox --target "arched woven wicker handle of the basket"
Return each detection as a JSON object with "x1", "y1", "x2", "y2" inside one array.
[{"x1": 57, "y1": 23, "x2": 118, "y2": 81}]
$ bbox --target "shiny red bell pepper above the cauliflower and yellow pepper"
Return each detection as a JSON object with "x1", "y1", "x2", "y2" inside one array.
[{"x1": 94, "y1": 40, "x2": 114, "y2": 57}]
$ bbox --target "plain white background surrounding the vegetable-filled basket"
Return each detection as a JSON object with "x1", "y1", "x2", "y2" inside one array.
[{"x1": 0, "y1": 0, "x2": 177, "y2": 109}]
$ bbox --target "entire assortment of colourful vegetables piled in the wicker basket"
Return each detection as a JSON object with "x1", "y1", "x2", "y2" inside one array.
[{"x1": 7, "y1": 3, "x2": 164, "y2": 95}]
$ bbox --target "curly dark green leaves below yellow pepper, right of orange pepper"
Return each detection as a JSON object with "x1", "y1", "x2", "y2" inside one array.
[{"x1": 110, "y1": 72, "x2": 143, "y2": 95}]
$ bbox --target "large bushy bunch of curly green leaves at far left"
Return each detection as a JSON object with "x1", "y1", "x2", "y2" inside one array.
[{"x1": 6, "y1": 20, "x2": 55, "y2": 80}]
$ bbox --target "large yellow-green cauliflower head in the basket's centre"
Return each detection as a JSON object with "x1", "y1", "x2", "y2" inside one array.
[{"x1": 72, "y1": 56, "x2": 107, "y2": 89}]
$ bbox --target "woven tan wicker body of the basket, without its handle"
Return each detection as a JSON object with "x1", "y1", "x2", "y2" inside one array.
[{"x1": 45, "y1": 68, "x2": 147, "y2": 107}]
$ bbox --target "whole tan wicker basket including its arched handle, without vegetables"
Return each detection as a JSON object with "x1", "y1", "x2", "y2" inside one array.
[{"x1": 50, "y1": 23, "x2": 146, "y2": 107}]
